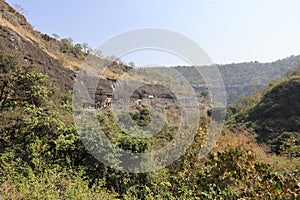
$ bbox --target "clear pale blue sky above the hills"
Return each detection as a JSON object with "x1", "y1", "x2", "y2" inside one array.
[{"x1": 6, "y1": 0, "x2": 300, "y2": 65}]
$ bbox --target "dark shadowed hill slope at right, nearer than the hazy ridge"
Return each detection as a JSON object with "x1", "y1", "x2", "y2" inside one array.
[{"x1": 229, "y1": 68, "x2": 300, "y2": 157}]
